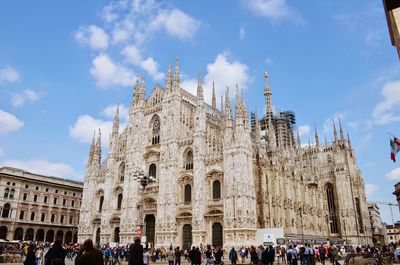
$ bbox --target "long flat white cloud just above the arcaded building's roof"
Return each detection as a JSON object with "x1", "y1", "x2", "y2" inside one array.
[{"x1": 2, "y1": 159, "x2": 76, "y2": 178}]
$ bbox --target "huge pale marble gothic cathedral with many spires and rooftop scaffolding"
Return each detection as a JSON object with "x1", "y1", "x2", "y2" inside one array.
[{"x1": 78, "y1": 61, "x2": 371, "y2": 247}]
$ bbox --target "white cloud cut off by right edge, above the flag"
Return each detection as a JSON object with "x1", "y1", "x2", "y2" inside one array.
[{"x1": 372, "y1": 80, "x2": 400, "y2": 125}]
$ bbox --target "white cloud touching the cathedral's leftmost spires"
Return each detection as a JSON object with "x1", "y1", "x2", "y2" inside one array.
[{"x1": 69, "y1": 115, "x2": 113, "y2": 148}]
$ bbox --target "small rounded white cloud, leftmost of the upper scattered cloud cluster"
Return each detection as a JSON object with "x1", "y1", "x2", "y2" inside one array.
[{"x1": 75, "y1": 25, "x2": 108, "y2": 50}]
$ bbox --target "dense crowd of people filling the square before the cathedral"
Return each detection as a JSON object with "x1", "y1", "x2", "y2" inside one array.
[{"x1": 0, "y1": 237, "x2": 400, "y2": 265}]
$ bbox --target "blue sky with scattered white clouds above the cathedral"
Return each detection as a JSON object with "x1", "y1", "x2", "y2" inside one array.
[{"x1": 0, "y1": 0, "x2": 400, "y2": 222}]
